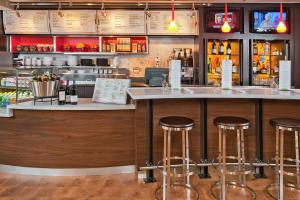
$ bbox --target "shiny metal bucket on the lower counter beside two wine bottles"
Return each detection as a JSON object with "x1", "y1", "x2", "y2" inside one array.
[{"x1": 31, "y1": 81, "x2": 58, "y2": 97}]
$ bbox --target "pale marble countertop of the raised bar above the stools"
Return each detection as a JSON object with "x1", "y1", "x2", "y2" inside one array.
[{"x1": 128, "y1": 86, "x2": 300, "y2": 100}]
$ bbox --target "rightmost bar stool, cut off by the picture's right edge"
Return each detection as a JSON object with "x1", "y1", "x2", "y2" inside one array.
[{"x1": 266, "y1": 118, "x2": 300, "y2": 200}]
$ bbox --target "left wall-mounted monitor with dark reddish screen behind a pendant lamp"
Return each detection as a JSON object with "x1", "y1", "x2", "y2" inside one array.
[{"x1": 205, "y1": 8, "x2": 243, "y2": 33}]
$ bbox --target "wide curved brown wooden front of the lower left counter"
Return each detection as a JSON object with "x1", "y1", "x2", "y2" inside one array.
[{"x1": 0, "y1": 110, "x2": 135, "y2": 168}]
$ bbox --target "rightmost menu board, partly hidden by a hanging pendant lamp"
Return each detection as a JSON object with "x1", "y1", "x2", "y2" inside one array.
[{"x1": 147, "y1": 10, "x2": 198, "y2": 35}]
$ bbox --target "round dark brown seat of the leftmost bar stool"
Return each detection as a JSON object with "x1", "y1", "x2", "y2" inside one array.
[{"x1": 159, "y1": 116, "x2": 195, "y2": 129}]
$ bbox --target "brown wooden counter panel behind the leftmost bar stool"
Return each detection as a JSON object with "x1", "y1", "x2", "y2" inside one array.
[{"x1": 153, "y1": 99, "x2": 201, "y2": 162}]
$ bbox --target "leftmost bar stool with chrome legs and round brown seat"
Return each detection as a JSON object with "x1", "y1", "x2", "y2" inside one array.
[{"x1": 155, "y1": 116, "x2": 199, "y2": 200}]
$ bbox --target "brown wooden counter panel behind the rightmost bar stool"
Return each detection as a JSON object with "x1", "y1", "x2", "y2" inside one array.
[{"x1": 263, "y1": 100, "x2": 300, "y2": 160}]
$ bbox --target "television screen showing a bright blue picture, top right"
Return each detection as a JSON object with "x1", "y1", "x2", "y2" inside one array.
[{"x1": 252, "y1": 11, "x2": 287, "y2": 33}]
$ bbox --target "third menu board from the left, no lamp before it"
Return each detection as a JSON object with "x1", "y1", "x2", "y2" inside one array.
[{"x1": 98, "y1": 10, "x2": 146, "y2": 35}]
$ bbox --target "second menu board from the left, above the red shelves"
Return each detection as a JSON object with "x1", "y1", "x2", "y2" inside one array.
[{"x1": 50, "y1": 10, "x2": 97, "y2": 34}]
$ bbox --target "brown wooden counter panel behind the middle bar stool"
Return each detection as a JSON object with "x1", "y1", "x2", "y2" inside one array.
[{"x1": 207, "y1": 99, "x2": 256, "y2": 160}]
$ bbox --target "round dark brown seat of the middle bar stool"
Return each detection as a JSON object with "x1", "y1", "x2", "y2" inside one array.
[{"x1": 214, "y1": 116, "x2": 250, "y2": 129}]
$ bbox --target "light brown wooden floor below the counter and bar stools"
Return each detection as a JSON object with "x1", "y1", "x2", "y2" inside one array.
[{"x1": 0, "y1": 168, "x2": 300, "y2": 200}]
